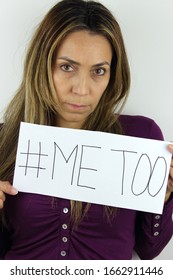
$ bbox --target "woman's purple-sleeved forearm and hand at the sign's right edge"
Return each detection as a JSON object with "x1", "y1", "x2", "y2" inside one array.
[{"x1": 135, "y1": 145, "x2": 173, "y2": 260}]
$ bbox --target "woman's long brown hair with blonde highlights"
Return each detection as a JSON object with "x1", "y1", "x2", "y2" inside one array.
[{"x1": 0, "y1": 0, "x2": 130, "y2": 224}]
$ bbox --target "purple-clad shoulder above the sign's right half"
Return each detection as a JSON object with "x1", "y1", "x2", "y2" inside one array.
[{"x1": 119, "y1": 115, "x2": 163, "y2": 140}]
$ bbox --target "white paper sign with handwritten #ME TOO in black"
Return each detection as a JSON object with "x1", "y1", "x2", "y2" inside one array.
[{"x1": 13, "y1": 123, "x2": 171, "y2": 214}]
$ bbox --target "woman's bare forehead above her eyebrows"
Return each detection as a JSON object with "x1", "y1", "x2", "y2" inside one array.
[{"x1": 56, "y1": 30, "x2": 112, "y2": 62}]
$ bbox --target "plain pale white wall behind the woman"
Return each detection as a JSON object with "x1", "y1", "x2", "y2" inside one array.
[{"x1": 0, "y1": 0, "x2": 173, "y2": 260}]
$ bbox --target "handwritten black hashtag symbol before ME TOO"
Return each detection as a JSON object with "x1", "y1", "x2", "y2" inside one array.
[{"x1": 19, "y1": 140, "x2": 48, "y2": 178}]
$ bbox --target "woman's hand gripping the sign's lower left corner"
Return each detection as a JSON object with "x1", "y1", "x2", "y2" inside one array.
[{"x1": 0, "y1": 181, "x2": 18, "y2": 209}]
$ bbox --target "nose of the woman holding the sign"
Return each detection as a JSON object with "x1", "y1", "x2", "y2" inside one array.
[{"x1": 72, "y1": 73, "x2": 90, "y2": 96}]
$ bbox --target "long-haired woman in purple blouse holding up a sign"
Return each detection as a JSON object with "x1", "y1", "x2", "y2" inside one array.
[{"x1": 0, "y1": 0, "x2": 173, "y2": 259}]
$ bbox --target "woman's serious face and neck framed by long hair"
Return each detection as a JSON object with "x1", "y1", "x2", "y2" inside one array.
[{"x1": 53, "y1": 31, "x2": 112, "y2": 128}]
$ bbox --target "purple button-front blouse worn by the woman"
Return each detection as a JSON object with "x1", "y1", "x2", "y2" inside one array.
[{"x1": 0, "y1": 116, "x2": 173, "y2": 260}]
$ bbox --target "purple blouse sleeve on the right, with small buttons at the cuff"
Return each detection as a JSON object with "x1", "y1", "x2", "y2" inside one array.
[{"x1": 135, "y1": 117, "x2": 173, "y2": 260}]
